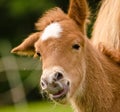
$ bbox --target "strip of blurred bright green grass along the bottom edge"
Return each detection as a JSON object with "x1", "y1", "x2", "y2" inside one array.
[{"x1": 0, "y1": 102, "x2": 73, "y2": 112}]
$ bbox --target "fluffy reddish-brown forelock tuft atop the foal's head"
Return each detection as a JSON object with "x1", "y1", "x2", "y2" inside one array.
[{"x1": 35, "y1": 7, "x2": 69, "y2": 31}]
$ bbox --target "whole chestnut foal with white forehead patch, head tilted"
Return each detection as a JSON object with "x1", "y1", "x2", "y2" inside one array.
[{"x1": 12, "y1": 0, "x2": 120, "y2": 112}]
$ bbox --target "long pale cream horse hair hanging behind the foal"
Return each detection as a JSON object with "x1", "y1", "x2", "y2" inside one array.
[{"x1": 92, "y1": 0, "x2": 120, "y2": 51}]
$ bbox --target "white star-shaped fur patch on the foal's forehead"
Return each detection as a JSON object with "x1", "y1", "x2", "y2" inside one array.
[{"x1": 40, "y1": 22, "x2": 62, "y2": 41}]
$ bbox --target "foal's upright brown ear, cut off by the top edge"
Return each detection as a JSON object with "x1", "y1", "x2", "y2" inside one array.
[{"x1": 68, "y1": 0, "x2": 89, "y2": 33}]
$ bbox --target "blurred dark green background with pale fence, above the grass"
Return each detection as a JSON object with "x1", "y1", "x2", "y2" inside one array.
[{"x1": 0, "y1": 0, "x2": 100, "y2": 112}]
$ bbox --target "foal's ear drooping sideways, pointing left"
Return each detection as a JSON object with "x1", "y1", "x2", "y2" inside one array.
[{"x1": 11, "y1": 32, "x2": 40, "y2": 56}]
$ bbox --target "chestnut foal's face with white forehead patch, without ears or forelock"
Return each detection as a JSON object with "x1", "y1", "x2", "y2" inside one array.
[{"x1": 35, "y1": 20, "x2": 85, "y2": 103}]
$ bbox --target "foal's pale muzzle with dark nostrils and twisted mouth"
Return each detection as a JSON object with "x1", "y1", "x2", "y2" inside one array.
[{"x1": 40, "y1": 68, "x2": 70, "y2": 100}]
